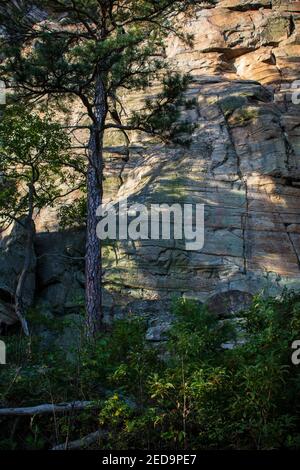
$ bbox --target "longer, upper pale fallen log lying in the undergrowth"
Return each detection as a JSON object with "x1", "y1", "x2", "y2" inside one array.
[{"x1": 0, "y1": 401, "x2": 100, "y2": 416}]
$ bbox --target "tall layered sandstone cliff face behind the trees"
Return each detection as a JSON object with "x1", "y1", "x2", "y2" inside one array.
[{"x1": 1, "y1": 0, "x2": 300, "y2": 324}]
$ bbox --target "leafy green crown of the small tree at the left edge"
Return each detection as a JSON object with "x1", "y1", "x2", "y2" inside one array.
[{"x1": 0, "y1": 106, "x2": 82, "y2": 221}]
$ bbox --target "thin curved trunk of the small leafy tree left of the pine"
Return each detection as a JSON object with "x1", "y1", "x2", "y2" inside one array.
[{"x1": 15, "y1": 184, "x2": 34, "y2": 336}]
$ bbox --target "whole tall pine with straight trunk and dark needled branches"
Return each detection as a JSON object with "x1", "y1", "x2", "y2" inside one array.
[{"x1": 0, "y1": 0, "x2": 203, "y2": 337}]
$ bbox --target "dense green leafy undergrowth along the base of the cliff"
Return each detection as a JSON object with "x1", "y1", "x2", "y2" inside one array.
[{"x1": 0, "y1": 292, "x2": 300, "y2": 449}]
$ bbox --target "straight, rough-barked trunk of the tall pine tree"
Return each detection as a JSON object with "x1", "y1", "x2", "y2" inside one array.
[{"x1": 85, "y1": 76, "x2": 107, "y2": 338}]
